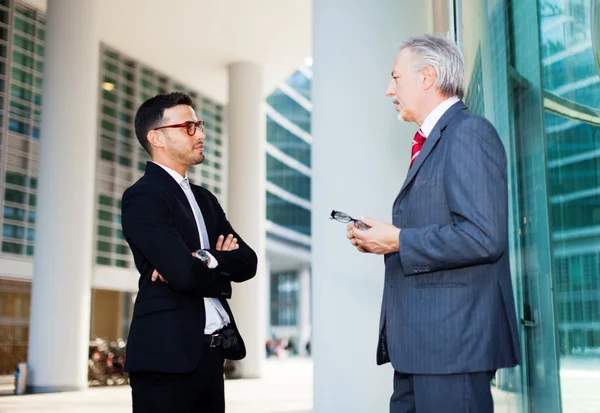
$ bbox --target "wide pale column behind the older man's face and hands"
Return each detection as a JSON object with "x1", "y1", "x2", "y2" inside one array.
[{"x1": 312, "y1": 0, "x2": 432, "y2": 413}]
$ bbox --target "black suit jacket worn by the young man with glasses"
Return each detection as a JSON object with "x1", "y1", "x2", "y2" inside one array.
[{"x1": 122, "y1": 162, "x2": 257, "y2": 373}]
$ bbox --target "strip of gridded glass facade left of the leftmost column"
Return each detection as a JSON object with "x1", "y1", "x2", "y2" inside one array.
[{"x1": 0, "y1": 1, "x2": 45, "y2": 257}]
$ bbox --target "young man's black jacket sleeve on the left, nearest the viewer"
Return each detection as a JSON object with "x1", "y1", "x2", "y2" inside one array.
[{"x1": 122, "y1": 186, "x2": 227, "y2": 294}]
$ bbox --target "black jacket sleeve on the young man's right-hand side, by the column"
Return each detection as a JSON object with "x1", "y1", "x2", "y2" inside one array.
[{"x1": 208, "y1": 193, "x2": 258, "y2": 282}]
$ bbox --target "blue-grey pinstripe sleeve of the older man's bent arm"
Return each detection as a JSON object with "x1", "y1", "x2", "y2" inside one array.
[{"x1": 399, "y1": 122, "x2": 508, "y2": 276}]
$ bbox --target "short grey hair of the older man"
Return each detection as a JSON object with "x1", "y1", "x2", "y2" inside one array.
[{"x1": 400, "y1": 35, "x2": 465, "y2": 99}]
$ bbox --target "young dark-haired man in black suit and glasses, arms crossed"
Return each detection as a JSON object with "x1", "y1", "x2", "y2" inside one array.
[{"x1": 122, "y1": 93, "x2": 257, "y2": 413}]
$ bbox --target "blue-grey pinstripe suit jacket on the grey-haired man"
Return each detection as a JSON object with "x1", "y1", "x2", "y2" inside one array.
[{"x1": 377, "y1": 102, "x2": 520, "y2": 374}]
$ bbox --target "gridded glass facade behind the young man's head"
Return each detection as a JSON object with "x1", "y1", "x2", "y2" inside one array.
[{"x1": 96, "y1": 46, "x2": 226, "y2": 268}]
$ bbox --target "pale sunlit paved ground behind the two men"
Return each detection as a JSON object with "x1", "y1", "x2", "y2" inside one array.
[{"x1": 0, "y1": 358, "x2": 600, "y2": 413}]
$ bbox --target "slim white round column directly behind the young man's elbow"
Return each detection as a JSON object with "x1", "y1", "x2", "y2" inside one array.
[{"x1": 227, "y1": 62, "x2": 268, "y2": 377}]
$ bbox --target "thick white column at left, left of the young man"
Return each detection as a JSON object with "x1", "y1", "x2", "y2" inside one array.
[{"x1": 28, "y1": 0, "x2": 100, "y2": 392}]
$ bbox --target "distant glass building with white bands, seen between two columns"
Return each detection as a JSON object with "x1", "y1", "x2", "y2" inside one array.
[{"x1": 266, "y1": 65, "x2": 312, "y2": 353}]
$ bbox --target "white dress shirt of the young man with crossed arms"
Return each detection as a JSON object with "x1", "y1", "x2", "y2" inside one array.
[{"x1": 154, "y1": 162, "x2": 230, "y2": 334}]
